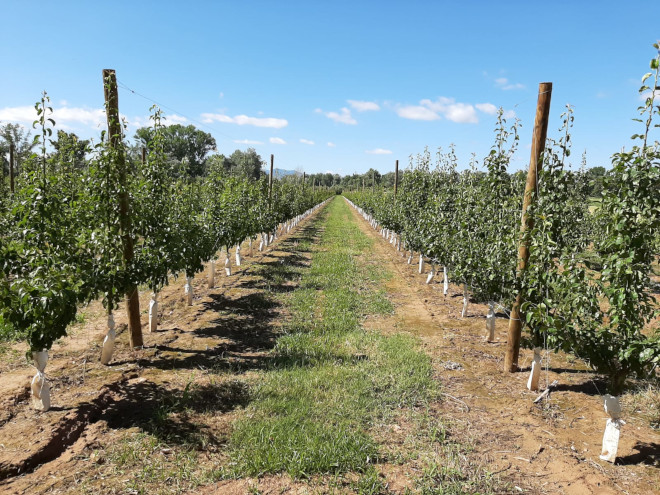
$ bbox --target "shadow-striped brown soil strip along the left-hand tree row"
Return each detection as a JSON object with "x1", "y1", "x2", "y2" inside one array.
[{"x1": 0, "y1": 214, "x2": 322, "y2": 494}]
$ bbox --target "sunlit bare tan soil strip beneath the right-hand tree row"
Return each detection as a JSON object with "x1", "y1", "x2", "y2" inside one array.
[{"x1": 351, "y1": 201, "x2": 660, "y2": 495}]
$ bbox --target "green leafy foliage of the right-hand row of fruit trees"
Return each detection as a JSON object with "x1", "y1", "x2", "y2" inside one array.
[{"x1": 347, "y1": 45, "x2": 660, "y2": 394}]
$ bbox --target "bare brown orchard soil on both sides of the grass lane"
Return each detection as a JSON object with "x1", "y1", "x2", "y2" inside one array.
[{"x1": 0, "y1": 198, "x2": 660, "y2": 494}]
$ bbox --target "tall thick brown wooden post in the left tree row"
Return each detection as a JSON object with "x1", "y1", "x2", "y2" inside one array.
[{"x1": 103, "y1": 69, "x2": 143, "y2": 347}]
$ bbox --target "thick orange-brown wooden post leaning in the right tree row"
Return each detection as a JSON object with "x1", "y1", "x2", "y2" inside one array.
[{"x1": 504, "y1": 83, "x2": 552, "y2": 373}]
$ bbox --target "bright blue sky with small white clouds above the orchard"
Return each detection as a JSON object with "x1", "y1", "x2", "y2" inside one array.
[{"x1": 0, "y1": 0, "x2": 660, "y2": 174}]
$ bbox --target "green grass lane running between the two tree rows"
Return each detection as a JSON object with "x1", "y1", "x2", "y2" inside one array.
[{"x1": 224, "y1": 198, "x2": 435, "y2": 486}]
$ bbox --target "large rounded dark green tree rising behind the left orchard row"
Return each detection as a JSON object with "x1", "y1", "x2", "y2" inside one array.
[{"x1": 135, "y1": 124, "x2": 216, "y2": 177}]
